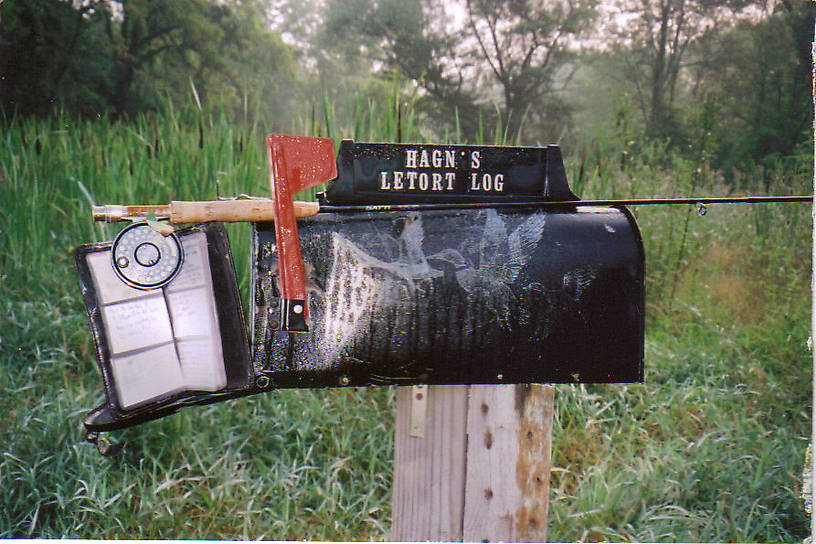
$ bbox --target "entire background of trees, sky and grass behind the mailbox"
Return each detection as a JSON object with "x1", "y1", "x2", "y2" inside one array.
[{"x1": 0, "y1": 0, "x2": 814, "y2": 541}]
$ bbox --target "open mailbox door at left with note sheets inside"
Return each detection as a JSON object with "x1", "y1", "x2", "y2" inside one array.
[{"x1": 75, "y1": 223, "x2": 255, "y2": 431}]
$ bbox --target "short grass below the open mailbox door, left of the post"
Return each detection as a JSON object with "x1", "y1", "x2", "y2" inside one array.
[{"x1": 0, "y1": 297, "x2": 393, "y2": 540}]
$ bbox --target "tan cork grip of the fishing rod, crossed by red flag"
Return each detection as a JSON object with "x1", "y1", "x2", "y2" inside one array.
[{"x1": 170, "y1": 200, "x2": 320, "y2": 224}]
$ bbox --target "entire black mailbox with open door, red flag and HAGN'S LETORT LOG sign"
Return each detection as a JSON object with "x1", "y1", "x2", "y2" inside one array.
[{"x1": 76, "y1": 135, "x2": 645, "y2": 431}]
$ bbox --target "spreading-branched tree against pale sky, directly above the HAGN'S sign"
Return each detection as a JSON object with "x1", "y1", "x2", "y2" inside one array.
[{"x1": 323, "y1": 0, "x2": 595, "y2": 139}]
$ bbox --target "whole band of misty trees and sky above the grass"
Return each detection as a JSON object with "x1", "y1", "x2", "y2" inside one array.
[{"x1": 0, "y1": 0, "x2": 814, "y2": 174}]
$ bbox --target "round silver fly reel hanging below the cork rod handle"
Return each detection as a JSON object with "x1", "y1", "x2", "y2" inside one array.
[{"x1": 111, "y1": 222, "x2": 184, "y2": 290}]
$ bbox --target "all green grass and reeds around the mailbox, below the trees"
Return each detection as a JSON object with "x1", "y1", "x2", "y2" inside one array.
[{"x1": 0, "y1": 99, "x2": 813, "y2": 542}]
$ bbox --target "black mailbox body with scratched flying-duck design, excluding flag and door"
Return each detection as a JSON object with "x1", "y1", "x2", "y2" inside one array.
[{"x1": 252, "y1": 206, "x2": 645, "y2": 387}]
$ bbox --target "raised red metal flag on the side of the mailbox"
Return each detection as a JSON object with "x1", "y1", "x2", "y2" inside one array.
[{"x1": 266, "y1": 134, "x2": 337, "y2": 332}]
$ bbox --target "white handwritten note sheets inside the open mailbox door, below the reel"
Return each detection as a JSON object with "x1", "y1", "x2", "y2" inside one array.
[{"x1": 87, "y1": 232, "x2": 227, "y2": 410}]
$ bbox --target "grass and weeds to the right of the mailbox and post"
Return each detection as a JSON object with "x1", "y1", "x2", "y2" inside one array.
[{"x1": 550, "y1": 129, "x2": 812, "y2": 542}]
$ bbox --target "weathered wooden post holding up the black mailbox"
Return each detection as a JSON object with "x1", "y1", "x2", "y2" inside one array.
[{"x1": 392, "y1": 385, "x2": 553, "y2": 542}]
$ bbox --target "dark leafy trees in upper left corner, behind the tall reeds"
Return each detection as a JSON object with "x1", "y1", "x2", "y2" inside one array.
[{"x1": 0, "y1": 0, "x2": 294, "y2": 117}]
